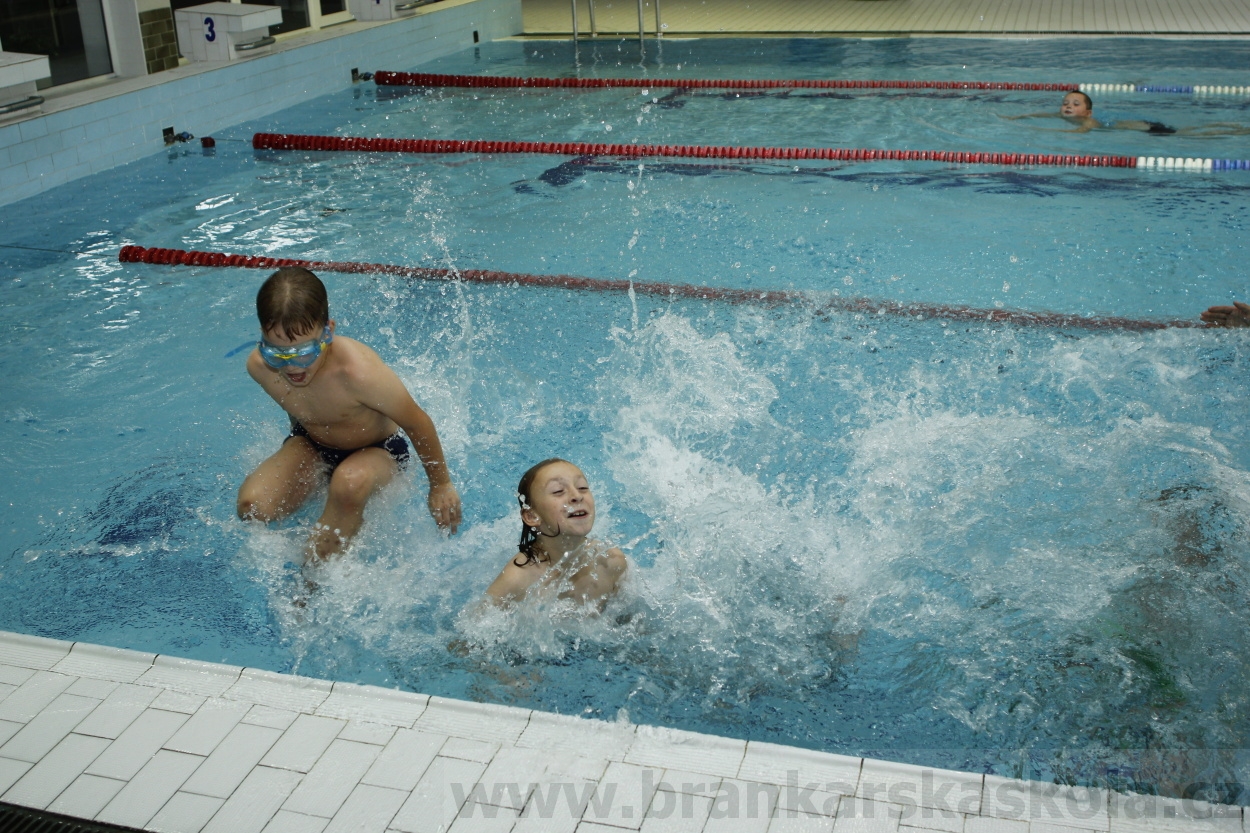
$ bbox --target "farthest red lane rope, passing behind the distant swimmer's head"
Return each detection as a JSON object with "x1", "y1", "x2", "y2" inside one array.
[{"x1": 366, "y1": 70, "x2": 1250, "y2": 95}]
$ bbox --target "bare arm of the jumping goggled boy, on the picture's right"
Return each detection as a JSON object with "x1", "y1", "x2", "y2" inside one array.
[{"x1": 361, "y1": 359, "x2": 460, "y2": 533}]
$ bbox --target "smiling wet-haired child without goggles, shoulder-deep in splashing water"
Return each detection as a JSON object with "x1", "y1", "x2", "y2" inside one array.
[{"x1": 486, "y1": 458, "x2": 629, "y2": 608}]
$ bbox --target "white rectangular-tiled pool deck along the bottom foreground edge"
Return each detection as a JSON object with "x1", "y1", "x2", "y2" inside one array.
[{"x1": 0, "y1": 632, "x2": 1246, "y2": 833}]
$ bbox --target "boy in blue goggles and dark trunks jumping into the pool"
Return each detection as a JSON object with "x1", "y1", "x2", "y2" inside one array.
[{"x1": 238, "y1": 266, "x2": 460, "y2": 559}]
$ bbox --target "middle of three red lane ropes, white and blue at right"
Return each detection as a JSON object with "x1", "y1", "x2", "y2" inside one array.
[{"x1": 251, "y1": 133, "x2": 1250, "y2": 171}]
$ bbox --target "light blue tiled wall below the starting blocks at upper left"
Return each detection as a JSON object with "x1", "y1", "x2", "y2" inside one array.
[{"x1": 0, "y1": 0, "x2": 521, "y2": 205}]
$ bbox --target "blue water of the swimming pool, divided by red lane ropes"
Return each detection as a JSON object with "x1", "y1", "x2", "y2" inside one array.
[{"x1": 0, "y1": 40, "x2": 1250, "y2": 800}]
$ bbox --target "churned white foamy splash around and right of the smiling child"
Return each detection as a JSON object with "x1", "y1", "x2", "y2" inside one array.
[{"x1": 227, "y1": 290, "x2": 1250, "y2": 770}]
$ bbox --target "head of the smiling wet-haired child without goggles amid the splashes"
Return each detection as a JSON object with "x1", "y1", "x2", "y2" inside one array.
[{"x1": 516, "y1": 457, "x2": 595, "y2": 567}]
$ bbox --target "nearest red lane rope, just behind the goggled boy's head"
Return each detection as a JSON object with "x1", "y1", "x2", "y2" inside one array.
[{"x1": 118, "y1": 246, "x2": 1205, "y2": 331}]
